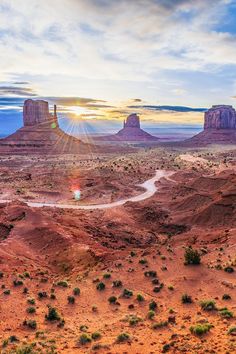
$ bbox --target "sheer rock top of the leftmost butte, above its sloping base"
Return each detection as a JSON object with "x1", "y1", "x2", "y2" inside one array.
[{"x1": 23, "y1": 99, "x2": 58, "y2": 127}]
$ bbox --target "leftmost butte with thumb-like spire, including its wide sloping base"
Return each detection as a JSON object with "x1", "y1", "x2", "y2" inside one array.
[{"x1": 0, "y1": 99, "x2": 97, "y2": 154}]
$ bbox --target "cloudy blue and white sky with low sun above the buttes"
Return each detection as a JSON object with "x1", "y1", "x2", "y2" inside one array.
[{"x1": 0, "y1": 0, "x2": 236, "y2": 135}]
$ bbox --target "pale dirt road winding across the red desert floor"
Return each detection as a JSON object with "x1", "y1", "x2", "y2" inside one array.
[{"x1": 0, "y1": 170, "x2": 174, "y2": 210}]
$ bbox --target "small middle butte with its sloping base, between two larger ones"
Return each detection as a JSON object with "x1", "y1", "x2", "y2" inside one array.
[{"x1": 97, "y1": 113, "x2": 159, "y2": 141}]
